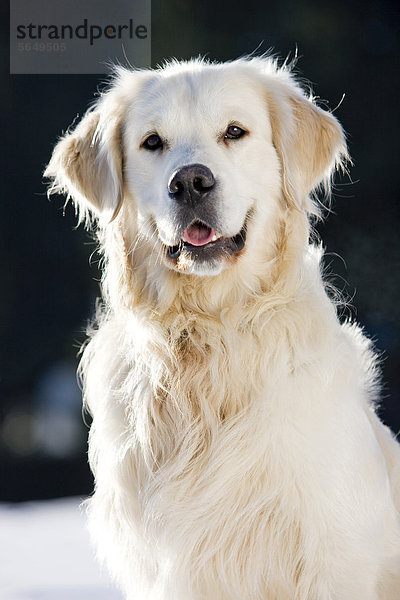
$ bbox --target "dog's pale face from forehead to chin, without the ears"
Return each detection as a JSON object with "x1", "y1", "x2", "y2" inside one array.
[{"x1": 123, "y1": 69, "x2": 280, "y2": 275}]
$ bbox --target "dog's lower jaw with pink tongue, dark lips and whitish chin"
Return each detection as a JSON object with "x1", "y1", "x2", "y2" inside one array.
[{"x1": 163, "y1": 219, "x2": 247, "y2": 276}]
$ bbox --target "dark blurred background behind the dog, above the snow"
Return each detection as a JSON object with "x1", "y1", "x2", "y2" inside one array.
[{"x1": 0, "y1": 0, "x2": 400, "y2": 501}]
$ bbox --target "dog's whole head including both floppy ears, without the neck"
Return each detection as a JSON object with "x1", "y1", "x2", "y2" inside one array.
[{"x1": 45, "y1": 59, "x2": 346, "y2": 275}]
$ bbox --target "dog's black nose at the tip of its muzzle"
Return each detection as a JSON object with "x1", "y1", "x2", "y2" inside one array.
[{"x1": 168, "y1": 164, "x2": 215, "y2": 203}]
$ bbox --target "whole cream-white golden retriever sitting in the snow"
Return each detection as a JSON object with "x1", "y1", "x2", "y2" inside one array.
[{"x1": 45, "y1": 58, "x2": 400, "y2": 600}]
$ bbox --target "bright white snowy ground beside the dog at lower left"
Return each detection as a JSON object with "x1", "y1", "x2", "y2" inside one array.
[{"x1": 0, "y1": 498, "x2": 122, "y2": 600}]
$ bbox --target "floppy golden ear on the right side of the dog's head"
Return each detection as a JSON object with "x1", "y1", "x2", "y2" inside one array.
[{"x1": 268, "y1": 74, "x2": 347, "y2": 213}]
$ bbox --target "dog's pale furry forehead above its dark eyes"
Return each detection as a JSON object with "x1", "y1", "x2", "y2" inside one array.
[{"x1": 132, "y1": 67, "x2": 267, "y2": 131}]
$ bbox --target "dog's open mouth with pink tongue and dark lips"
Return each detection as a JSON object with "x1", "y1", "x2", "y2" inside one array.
[{"x1": 166, "y1": 219, "x2": 247, "y2": 260}]
